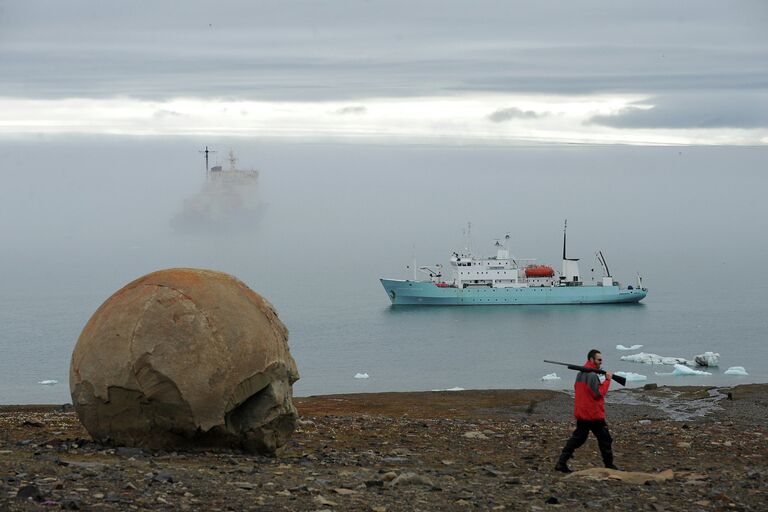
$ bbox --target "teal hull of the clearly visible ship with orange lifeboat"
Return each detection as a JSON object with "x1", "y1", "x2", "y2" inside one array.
[{"x1": 381, "y1": 279, "x2": 648, "y2": 306}]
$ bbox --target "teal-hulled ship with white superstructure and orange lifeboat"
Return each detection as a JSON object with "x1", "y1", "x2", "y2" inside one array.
[{"x1": 381, "y1": 223, "x2": 648, "y2": 306}]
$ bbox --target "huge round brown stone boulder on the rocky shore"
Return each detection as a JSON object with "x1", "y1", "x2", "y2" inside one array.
[{"x1": 69, "y1": 268, "x2": 299, "y2": 454}]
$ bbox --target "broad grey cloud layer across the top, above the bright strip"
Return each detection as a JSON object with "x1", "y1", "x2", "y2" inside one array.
[{"x1": 0, "y1": 0, "x2": 768, "y2": 101}]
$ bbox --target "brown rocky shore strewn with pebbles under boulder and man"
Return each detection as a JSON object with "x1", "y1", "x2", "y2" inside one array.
[{"x1": 0, "y1": 384, "x2": 768, "y2": 512}]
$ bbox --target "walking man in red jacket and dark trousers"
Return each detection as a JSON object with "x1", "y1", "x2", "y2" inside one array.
[{"x1": 555, "y1": 349, "x2": 618, "y2": 473}]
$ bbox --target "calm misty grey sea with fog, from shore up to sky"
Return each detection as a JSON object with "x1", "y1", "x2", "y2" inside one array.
[{"x1": 0, "y1": 138, "x2": 768, "y2": 404}]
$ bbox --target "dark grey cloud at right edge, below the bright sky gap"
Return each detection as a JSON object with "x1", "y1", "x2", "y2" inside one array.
[{"x1": 588, "y1": 93, "x2": 768, "y2": 129}]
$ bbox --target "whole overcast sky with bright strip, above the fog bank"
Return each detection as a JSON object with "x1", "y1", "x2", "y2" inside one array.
[{"x1": 0, "y1": 0, "x2": 768, "y2": 145}]
